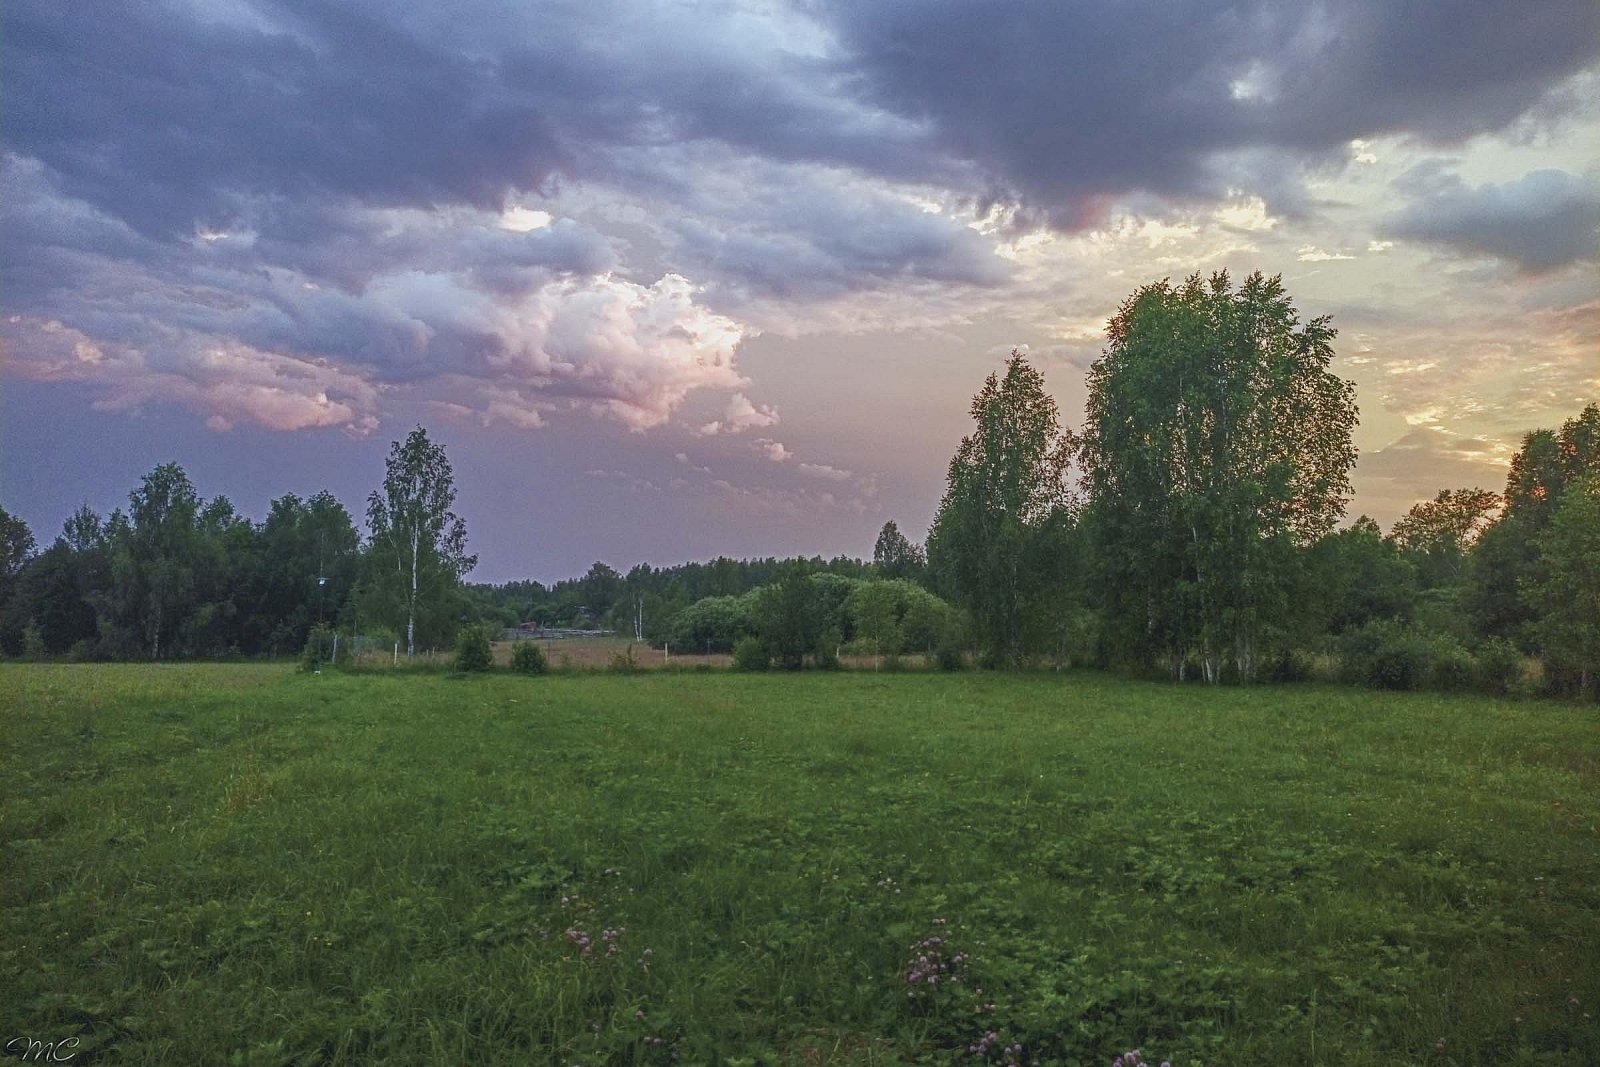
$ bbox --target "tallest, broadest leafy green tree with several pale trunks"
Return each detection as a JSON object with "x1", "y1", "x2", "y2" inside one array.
[{"x1": 1082, "y1": 272, "x2": 1357, "y2": 681}]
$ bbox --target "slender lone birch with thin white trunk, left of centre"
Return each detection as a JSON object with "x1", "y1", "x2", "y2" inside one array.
[{"x1": 366, "y1": 426, "x2": 478, "y2": 656}]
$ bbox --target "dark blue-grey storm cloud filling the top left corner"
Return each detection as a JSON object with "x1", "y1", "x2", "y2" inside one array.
[{"x1": 5, "y1": 0, "x2": 562, "y2": 237}]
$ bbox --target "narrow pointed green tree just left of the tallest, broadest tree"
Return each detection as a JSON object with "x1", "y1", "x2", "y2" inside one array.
[{"x1": 928, "y1": 352, "x2": 1074, "y2": 665}]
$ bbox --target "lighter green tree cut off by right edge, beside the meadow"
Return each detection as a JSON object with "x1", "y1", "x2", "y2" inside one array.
[{"x1": 1526, "y1": 474, "x2": 1600, "y2": 694}]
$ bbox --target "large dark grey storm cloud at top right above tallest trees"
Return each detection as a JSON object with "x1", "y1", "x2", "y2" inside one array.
[{"x1": 829, "y1": 0, "x2": 1600, "y2": 226}]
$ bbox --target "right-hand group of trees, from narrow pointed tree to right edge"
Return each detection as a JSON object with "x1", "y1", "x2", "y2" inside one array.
[{"x1": 908, "y1": 272, "x2": 1600, "y2": 694}]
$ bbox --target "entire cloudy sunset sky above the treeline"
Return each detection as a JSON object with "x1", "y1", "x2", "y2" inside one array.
[{"x1": 0, "y1": 0, "x2": 1600, "y2": 581}]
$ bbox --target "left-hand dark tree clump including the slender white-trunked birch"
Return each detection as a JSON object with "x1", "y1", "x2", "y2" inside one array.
[{"x1": 0, "y1": 427, "x2": 474, "y2": 662}]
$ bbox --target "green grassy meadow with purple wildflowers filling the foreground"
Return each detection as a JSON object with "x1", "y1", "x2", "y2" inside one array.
[{"x1": 0, "y1": 665, "x2": 1600, "y2": 1067}]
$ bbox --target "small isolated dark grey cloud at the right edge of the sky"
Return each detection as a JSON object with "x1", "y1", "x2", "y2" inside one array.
[{"x1": 1384, "y1": 165, "x2": 1600, "y2": 272}]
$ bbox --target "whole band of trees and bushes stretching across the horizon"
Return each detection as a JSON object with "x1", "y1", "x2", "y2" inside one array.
[{"x1": 0, "y1": 274, "x2": 1600, "y2": 699}]
